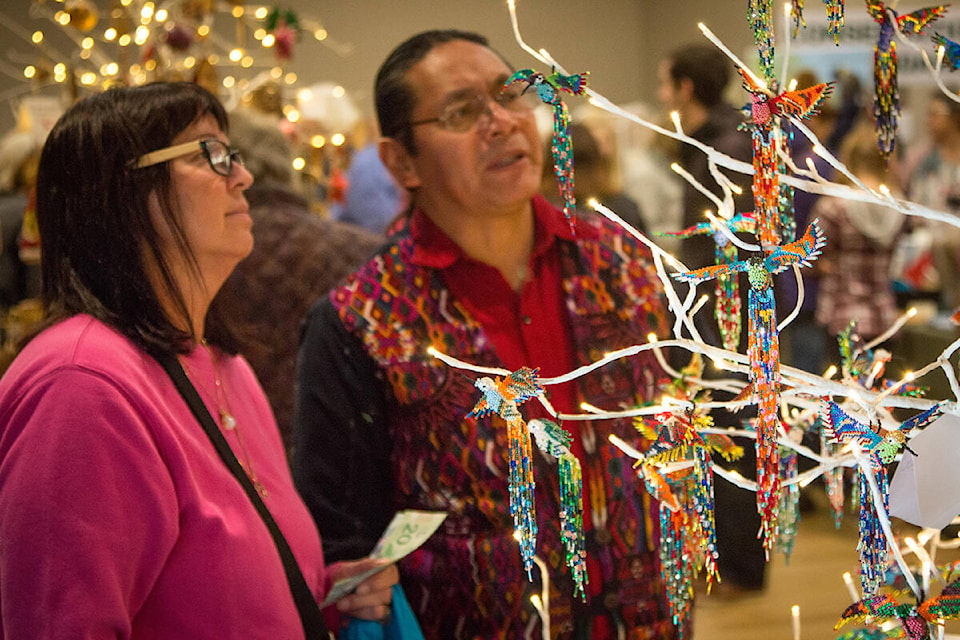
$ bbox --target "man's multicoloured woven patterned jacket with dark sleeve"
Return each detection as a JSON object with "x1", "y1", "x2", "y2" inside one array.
[{"x1": 292, "y1": 202, "x2": 676, "y2": 639}]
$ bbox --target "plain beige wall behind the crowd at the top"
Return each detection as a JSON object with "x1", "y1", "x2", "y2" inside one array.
[{"x1": 0, "y1": 0, "x2": 751, "y2": 131}]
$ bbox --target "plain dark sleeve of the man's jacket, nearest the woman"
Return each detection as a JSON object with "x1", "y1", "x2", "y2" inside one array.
[{"x1": 291, "y1": 299, "x2": 393, "y2": 562}]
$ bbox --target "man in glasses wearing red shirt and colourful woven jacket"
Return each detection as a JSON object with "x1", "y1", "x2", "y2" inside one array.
[{"x1": 292, "y1": 31, "x2": 676, "y2": 640}]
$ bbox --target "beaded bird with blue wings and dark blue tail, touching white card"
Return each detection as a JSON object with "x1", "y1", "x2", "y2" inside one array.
[{"x1": 821, "y1": 400, "x2": 941, "y2": 594}]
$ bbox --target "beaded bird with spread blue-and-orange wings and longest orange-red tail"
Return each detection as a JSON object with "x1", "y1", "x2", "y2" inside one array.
[{"x1": 673, "y1": 220, "x2": 826, "y2": 555}]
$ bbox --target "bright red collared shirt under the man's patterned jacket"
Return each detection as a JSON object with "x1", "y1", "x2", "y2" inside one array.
[{"x1": 410, "y1": 196, "x2": 589, "y2": 418}]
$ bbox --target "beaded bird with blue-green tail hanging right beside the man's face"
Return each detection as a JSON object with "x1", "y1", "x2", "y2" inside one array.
[{"x1": 503, "y1": 69, "x2": 589, "y2": 229}]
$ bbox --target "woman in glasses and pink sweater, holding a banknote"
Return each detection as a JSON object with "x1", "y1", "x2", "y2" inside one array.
[{"x1": 0, "y1": 83, "x2": 396, "y2": 640}]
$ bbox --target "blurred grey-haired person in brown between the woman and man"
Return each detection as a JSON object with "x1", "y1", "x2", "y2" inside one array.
[{"x1": 213, "y1": 109, "x2": 383, "y2": 445}]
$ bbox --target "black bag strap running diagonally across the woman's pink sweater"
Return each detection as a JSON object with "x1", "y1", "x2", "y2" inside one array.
[{"x1": 157, "y1": 353, "x2": 330, "y2": 640}]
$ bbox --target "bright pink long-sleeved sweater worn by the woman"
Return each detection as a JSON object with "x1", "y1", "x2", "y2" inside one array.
[{"x1": 0, "y1": 316, "x2": 326, "y2": 640}]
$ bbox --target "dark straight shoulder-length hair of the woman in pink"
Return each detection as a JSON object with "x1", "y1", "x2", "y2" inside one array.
[{"x1": 37, "y1": 82, "x2": 240, "y2": 354}]
